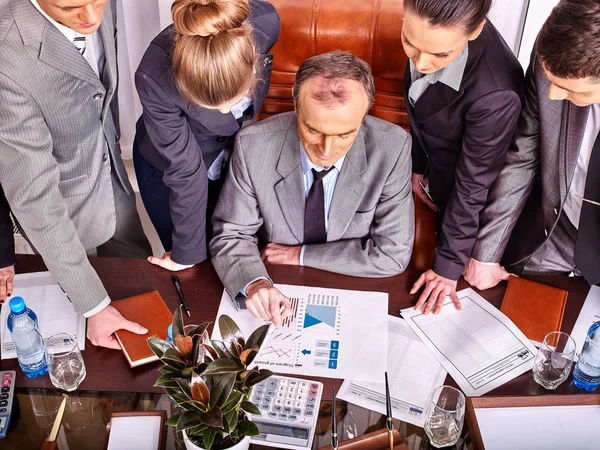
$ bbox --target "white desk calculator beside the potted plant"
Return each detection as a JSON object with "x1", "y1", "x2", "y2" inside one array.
[{"x1": 250, "y1": 375, "x2": 323, "y2": 450}]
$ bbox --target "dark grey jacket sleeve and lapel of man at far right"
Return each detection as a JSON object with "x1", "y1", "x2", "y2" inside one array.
[{"x1": 472, "y1": 50, "x2": 589, "y2": 265}]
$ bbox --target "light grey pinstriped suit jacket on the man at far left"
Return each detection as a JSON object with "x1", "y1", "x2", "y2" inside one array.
[{"x1": 0, "y1": 0, "x2": 131, "y2": 313}]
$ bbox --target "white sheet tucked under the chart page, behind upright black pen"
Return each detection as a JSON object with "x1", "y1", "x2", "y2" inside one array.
[{"x1": 337, "y1": 316, "x2": 447, "y2": 427}]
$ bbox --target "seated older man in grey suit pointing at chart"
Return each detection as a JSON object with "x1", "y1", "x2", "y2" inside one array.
[{"x1": 210, "y1": 51, "x2": 414, "y2": 325}]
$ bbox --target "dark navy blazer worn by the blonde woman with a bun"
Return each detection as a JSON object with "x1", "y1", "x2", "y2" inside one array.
[{"x1": 135, "y1": 0, "x2": 281, "y2": 264}]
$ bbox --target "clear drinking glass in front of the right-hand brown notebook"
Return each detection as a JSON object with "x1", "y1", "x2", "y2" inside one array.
[{"x1": 533, "y1": 331, "x2": 575, "y2": 389}]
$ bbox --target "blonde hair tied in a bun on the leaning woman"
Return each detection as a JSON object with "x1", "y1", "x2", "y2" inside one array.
[{"x1": 171, "y1": 0, "x2": 256, "y2": 107}]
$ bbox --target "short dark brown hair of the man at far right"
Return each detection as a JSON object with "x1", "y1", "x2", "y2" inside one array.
[{"x1": 537, "y1": 0, "x2": 600, "y2": 79}]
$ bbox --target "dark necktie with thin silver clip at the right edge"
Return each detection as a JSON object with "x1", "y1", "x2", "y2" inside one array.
[{"x1": 575, "y1": 134, "x2": 600, "y2": 285}]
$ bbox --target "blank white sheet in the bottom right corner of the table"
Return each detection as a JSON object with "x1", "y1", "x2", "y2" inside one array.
[{"x1": 475, "y1": 405, "x2": 600, "y2": 450}]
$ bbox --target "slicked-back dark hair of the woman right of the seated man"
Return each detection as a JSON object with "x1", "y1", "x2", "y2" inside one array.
[{"x1": 404, "y1": 0, "x2": 492, "y2": 34}]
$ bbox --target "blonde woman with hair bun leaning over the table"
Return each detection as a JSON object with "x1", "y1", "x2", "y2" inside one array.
[{"x1": 133, "y1": 0, "x2": 281, "y2": 271}]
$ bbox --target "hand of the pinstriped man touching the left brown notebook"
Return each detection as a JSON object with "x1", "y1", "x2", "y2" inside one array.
[{"x1": 87, "y1": 305, "x2": 148, "y2": 350}]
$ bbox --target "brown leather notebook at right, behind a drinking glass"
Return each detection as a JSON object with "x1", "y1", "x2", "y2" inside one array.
[{"x1": 500, "y1": 277, "x2": 569, "y2": 342}]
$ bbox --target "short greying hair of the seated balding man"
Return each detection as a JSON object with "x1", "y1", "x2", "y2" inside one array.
[{"x1": 294, "y1": 50, "x2": 375, "y2": 109}]
